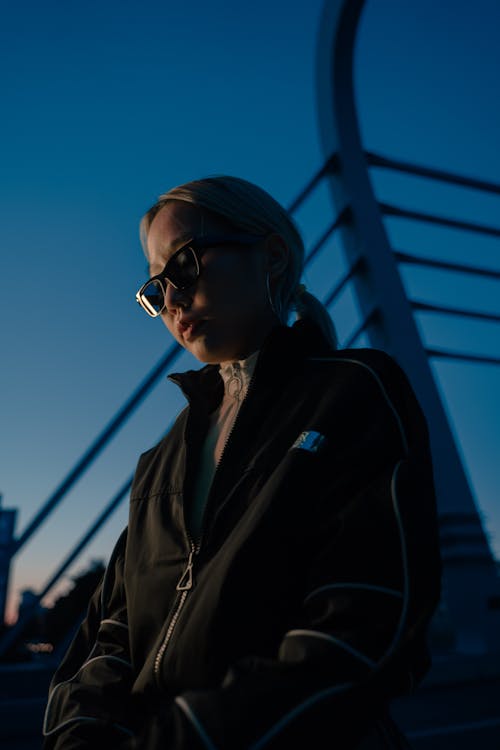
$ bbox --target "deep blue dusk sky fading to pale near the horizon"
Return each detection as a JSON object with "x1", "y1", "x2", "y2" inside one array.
[{"x1": 0, "y1": 0, "x2": 500, "y2": 624}]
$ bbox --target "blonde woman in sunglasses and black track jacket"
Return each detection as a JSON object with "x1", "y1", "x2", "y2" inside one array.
[{"x1": 44, "y1": 177, "x2": 440, "y2": 750}]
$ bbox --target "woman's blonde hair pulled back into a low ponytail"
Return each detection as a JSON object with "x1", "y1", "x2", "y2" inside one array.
[{"x1": 140, "y1": 175, "x2": 337, "y2": 348}]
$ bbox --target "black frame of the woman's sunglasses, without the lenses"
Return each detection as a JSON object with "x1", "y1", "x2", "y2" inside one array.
[{"x1": 135, "y1": 232, "x2": 266, "y2": 318}]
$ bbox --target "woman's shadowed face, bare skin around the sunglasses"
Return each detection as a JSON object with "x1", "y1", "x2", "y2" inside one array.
[{"x1": 147, "y1": 201, "x2": 277, "y2": 364}]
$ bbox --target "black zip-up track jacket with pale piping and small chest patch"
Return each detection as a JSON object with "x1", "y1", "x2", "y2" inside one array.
[{"x1": 44, "y1": 321, "x2": 440, "y2": 750}]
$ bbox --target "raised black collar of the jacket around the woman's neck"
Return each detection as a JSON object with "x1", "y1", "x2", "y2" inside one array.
[{"x1": 168, "y1": 318, "x2": 332, "y2": 412}]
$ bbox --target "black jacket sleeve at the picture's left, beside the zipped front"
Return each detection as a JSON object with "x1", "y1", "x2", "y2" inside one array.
[{"x1": 43, "y1": 530, "x2": 136, "y2": 750}]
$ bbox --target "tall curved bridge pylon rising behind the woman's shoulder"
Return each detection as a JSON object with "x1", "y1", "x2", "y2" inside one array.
[{"x1": 317, "y1": 0, "x2": 500, "y2": 653}]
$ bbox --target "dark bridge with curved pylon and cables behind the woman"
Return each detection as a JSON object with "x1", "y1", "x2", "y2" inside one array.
[{"x1": 0, "y1": 0, "x2": 500, "y2": 750}]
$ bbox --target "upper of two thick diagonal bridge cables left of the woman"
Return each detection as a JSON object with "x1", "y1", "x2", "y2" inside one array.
[{"x1": 12, "y1": 343, "x2": 182, "y2": 556}]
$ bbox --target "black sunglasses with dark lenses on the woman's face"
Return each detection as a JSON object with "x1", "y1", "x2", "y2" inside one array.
[{"x1": 135, "y1": 233, "x2": 265, "y2": 318}]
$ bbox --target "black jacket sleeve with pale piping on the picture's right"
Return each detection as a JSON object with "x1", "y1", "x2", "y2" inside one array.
[{"x1": 125, "y1": 353, "x2": 441, "y2": 750}]
